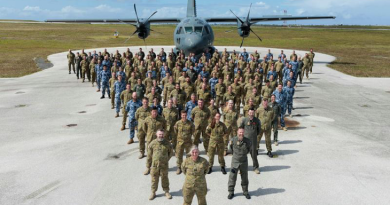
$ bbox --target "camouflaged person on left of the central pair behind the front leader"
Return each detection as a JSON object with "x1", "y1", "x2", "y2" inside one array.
[{"x1": 174, "y1": 110, "x2": 195, "y2": 174}]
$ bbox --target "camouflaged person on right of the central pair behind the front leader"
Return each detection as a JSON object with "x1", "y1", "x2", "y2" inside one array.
[{"x1": 206, "y1": 113, "x2": 230, "y2": 174}]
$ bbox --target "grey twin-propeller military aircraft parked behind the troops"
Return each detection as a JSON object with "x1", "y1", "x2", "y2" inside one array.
[{"x1": 46, "y1": 0, "x2": 336, "y2": 55}]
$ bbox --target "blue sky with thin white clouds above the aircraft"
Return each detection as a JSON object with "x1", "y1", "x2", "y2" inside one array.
[{"x1": 0, "y1": 0, "x2": 390, "y2": 25}]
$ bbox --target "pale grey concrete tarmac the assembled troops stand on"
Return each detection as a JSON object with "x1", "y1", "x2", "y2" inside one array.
[{"x1": 0, "y1": 46, "x2": 390, "y2": 205}]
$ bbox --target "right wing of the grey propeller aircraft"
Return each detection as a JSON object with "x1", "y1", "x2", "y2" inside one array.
[{"x1": 205, "y1": 16, "x2": 336, "y2": 23}]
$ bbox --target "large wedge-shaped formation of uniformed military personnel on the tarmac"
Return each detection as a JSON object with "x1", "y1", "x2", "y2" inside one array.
[{"x1": 67, "y1": 48, "x2": 315, "y2": 204}]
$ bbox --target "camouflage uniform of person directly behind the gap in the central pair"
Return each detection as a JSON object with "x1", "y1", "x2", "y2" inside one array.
[{"x1": 191, "y1": 106, "x2": 211, "y2": 152}]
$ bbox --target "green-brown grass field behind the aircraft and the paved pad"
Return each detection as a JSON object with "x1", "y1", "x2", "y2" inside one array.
[{"x1": 0, "y1": 23, "x2": 390, "y2": 78}]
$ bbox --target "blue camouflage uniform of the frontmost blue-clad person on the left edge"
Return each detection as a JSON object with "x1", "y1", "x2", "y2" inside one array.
[{"x1": 126, "y1": 100, "x2": 142, "y2": 139}]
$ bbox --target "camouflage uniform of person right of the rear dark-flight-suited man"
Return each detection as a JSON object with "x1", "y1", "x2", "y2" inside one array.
[{"x1": 256, "y1": 106, "x2": 275, "y2": 152}]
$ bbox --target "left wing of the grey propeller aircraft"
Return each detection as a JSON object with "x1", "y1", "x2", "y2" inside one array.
[{"x1": 45, "y1": 18, "x2": 181, "y2": 23}]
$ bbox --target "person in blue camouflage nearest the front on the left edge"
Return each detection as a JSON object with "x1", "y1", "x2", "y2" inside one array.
[{"x1": 125, "y1": 91, "x2": 145, "y2": 143}]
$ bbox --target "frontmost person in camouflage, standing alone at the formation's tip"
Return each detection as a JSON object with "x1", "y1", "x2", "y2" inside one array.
[{"x1": 181, "y1": 146, "x2": 210, "y2": 205}]
